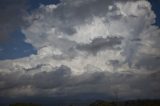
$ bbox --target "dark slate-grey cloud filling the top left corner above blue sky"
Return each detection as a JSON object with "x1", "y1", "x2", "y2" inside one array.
[{"x1": 0, "y1": 0, "x2": 27, "y2": 41}]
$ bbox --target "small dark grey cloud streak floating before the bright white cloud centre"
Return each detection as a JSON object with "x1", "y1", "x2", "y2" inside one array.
[{"x1": 77, "y1": 37, "x2": 123, "y2": 54}]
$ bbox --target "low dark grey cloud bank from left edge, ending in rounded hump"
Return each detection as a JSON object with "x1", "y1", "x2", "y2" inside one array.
[{"x1": 0, "y1": 65, "x2": 71, "y2": 90}]
